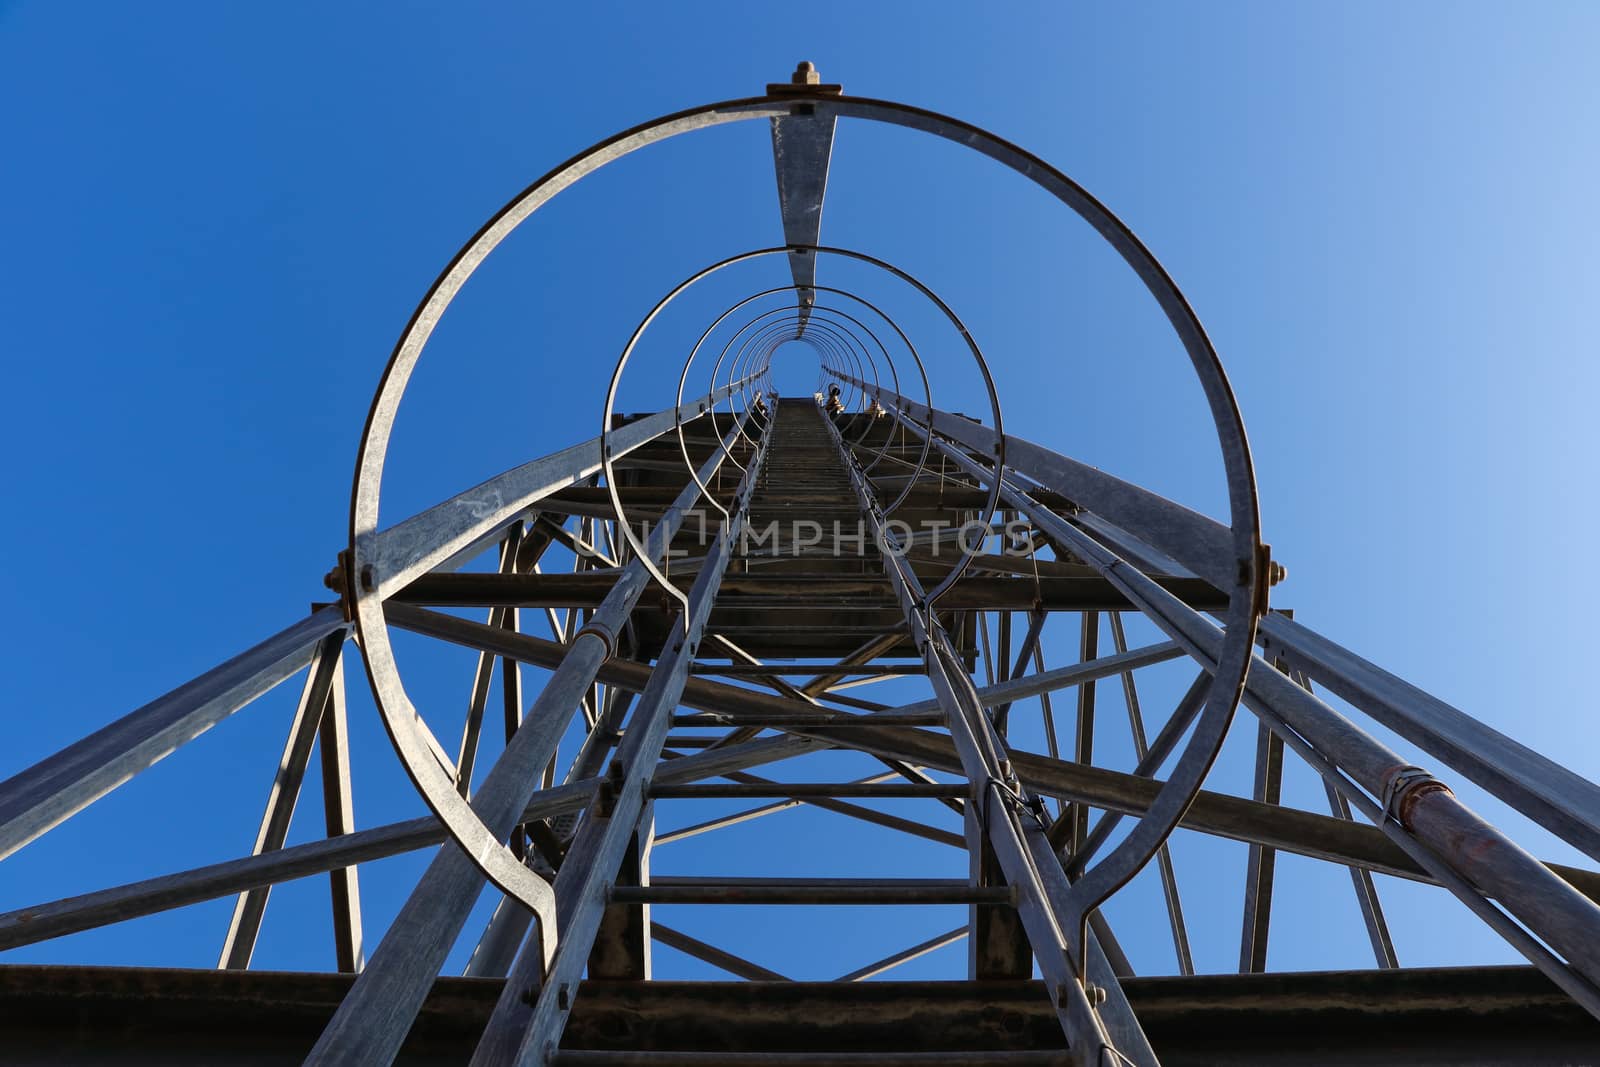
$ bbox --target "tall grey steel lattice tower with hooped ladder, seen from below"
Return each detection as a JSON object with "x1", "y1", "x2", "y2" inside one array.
[{"x1": 0, "y1": 64, "x2": 1600, "y2": 1067}]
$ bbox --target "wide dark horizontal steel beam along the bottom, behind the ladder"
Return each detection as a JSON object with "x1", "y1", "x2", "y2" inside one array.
[{"x1": 0, "y1": 966, "x2": 1600, "y2": 1067}]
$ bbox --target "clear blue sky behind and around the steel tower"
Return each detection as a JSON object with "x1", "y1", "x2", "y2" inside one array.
[{"x1": 0, "y1": 3, "x2": 1600, "y2": 977}]
